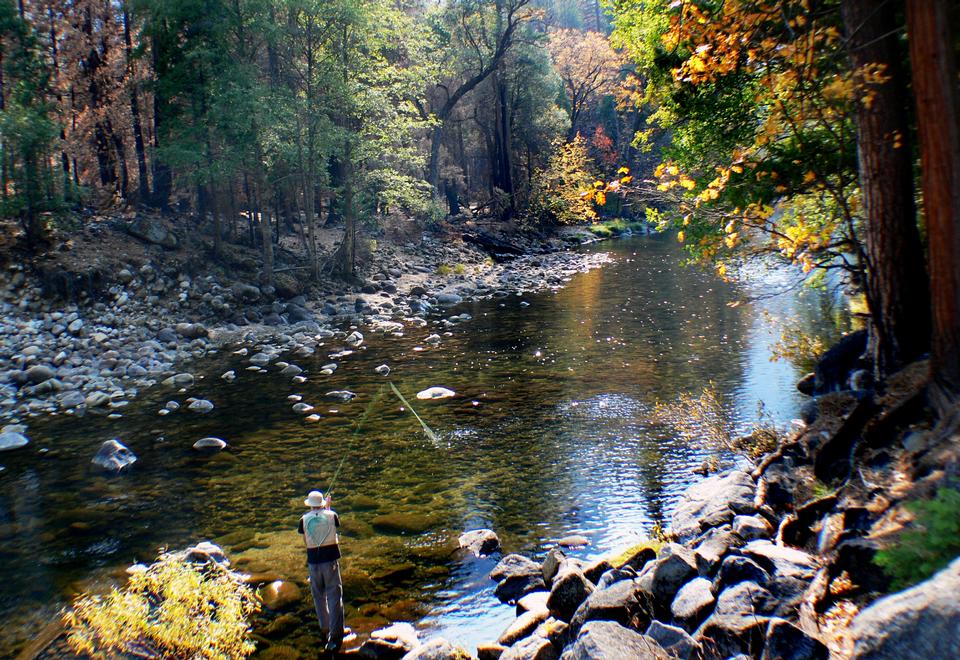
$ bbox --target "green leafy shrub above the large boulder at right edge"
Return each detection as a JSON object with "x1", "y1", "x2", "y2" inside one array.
[{"x1": 874, "y1": 488, "x2": 960, "y2": 589}]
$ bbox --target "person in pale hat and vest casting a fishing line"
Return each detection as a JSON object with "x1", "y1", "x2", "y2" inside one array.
[{"x1": 298, "y1": 490, "x2": 344, "y2": 651}]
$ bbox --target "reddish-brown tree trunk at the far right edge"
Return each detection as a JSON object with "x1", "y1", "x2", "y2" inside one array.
[{"x1": 907, "y1": 0, "x2": 960, "y2": 416}]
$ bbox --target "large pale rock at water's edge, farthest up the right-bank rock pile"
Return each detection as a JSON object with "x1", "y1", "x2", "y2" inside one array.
[{"x1": 670, "y1": 470, "x2": 756, "y2": 543}]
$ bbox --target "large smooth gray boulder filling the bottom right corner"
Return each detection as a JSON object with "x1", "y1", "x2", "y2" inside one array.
[{"x1": 849, "y1": 558, "x2": 960, "y2": 660}]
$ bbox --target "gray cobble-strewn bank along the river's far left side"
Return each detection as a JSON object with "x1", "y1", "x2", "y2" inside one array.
[{"x1": 0, "y1": 222, "x2": 605, "y2": 438}]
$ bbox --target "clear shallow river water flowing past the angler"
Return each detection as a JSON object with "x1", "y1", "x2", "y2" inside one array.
[{"x1": 0, "y1": 237, "x2": 848, "y2": 655}]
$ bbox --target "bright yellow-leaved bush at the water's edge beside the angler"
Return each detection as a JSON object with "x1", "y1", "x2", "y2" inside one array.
[{"x1": 64, "y1": 554, "x2": 259, "y2": 659}]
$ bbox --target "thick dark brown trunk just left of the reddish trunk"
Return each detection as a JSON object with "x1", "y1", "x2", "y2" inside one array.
[{"x1": 843, "y1": 0, "x2": 930, "y2": 376}]
